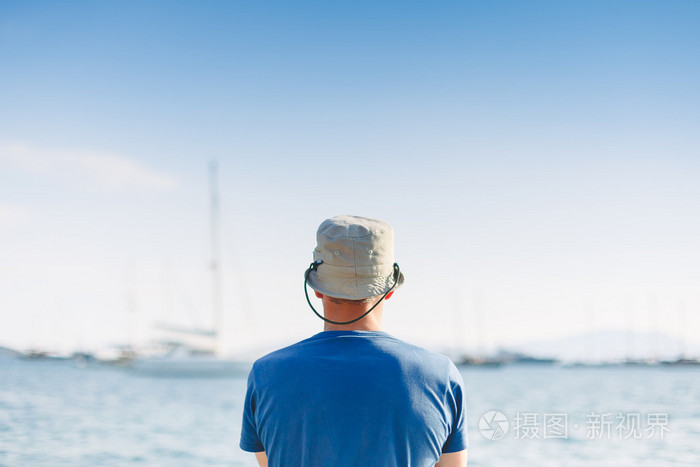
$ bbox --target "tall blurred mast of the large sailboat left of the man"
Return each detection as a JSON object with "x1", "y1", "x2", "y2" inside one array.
[{"x1": 209, "y1": 161, "x2": 224, "y2": 356}]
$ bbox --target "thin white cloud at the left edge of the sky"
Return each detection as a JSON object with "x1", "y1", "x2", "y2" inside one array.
[{"x1": 0, "y1": 143, "x2": 177, "y2": 192}]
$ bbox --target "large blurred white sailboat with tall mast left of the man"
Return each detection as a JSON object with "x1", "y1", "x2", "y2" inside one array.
[{"x1": 129, "y1": 162, "x2": 251, "y2": 378}]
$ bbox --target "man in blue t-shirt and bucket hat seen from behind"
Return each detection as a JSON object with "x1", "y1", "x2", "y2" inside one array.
[{"x1": 240, "y1": 216, "x2": 468, "y2": 467}]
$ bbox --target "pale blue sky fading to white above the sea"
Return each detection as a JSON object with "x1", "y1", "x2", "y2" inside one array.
[{"x1": 0, "y1": 1, "x2": 700, "y2": 358}]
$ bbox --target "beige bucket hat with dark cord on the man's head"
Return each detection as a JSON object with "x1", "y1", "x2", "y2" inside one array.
[{"x1": 307, "y1": 216, "x2": 404, "y2": 300}]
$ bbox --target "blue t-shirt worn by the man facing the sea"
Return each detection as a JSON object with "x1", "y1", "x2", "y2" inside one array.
[{"x1": 240, "y1": 331, "x2": 468, "y2": 467}]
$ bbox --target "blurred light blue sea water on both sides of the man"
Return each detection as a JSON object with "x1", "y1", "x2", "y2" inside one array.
[{"x1": 0, "y1": 359, "x2": 700, "y2": 467}]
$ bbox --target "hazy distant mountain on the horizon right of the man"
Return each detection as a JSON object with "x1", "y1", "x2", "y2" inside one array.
[{"x1": 509, "y1": 330, "x2": 700, "y2": 361}]
